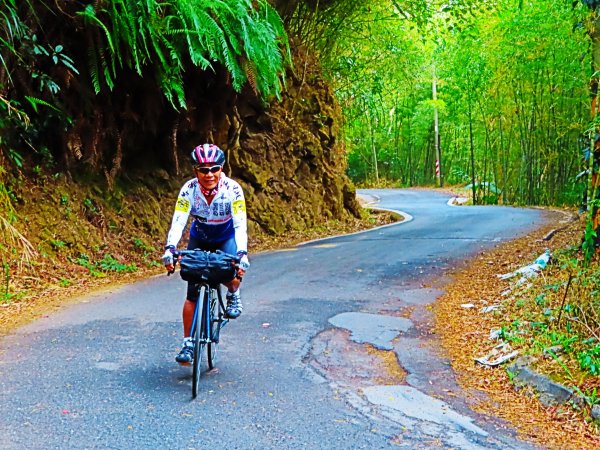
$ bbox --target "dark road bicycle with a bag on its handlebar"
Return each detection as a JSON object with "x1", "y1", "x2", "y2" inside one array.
[{"x1": 171, "y1": 249, "x2": 240, "y2": 398}]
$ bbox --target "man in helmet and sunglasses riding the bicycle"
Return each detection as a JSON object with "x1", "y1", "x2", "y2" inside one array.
[{"x1": 162, "y1": 144, "x2": 250, "y2": 365}]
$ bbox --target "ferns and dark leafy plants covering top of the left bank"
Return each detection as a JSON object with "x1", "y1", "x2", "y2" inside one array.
[{"x1": 0, "y1": 0, "x2": 291, "y2": 179}]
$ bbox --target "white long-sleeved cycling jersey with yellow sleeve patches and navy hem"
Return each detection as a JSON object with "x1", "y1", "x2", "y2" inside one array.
[{"x1": 167, "y1": 173, "x2": 248, "y2": 252}]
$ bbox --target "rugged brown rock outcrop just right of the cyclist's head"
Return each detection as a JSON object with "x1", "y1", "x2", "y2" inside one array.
[{"x1": 226, "y1": 45, "x2": 360, "y2": 233}]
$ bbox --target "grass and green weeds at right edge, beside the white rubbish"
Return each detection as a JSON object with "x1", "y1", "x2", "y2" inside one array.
[{"x1": 500, "y1": 250, "x2": 600, "y2": 386}]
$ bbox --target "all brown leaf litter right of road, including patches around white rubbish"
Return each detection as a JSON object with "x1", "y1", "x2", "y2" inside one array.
[{"x1": 434, "y1": 212, "x2": 600, "y2": 449}]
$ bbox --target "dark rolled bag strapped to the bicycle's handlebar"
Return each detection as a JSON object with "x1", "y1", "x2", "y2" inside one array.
[{"x1": 179, "y1": 251, "x2": 236, "y2": 283}]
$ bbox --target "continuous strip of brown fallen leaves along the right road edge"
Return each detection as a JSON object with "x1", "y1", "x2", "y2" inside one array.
[{"x1": 435, "y1": 213, "x2": 600, "y2": 449}]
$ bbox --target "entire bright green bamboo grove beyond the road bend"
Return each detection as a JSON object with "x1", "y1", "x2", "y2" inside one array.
[{"x1": 328, "y1": 0, "x2": 592, "y2": 204}]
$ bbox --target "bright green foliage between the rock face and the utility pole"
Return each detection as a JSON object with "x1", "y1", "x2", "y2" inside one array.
[{"x1": 323, "y1": 2, "x2": 434, "y2": 185}]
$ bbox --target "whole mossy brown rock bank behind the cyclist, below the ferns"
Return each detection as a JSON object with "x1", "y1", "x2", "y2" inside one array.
[{"x1": 0, "y1": 41, "x2": 360, "y2": 292}]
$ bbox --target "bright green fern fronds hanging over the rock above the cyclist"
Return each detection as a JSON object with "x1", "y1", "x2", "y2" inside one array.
[{"x1": 78, "y1": 0, "x2": 290, "y2": 108}]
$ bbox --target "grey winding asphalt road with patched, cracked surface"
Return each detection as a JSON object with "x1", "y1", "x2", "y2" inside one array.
[{"x1": 0, "y1": 190, "x2": 544, "y2": 449}]
